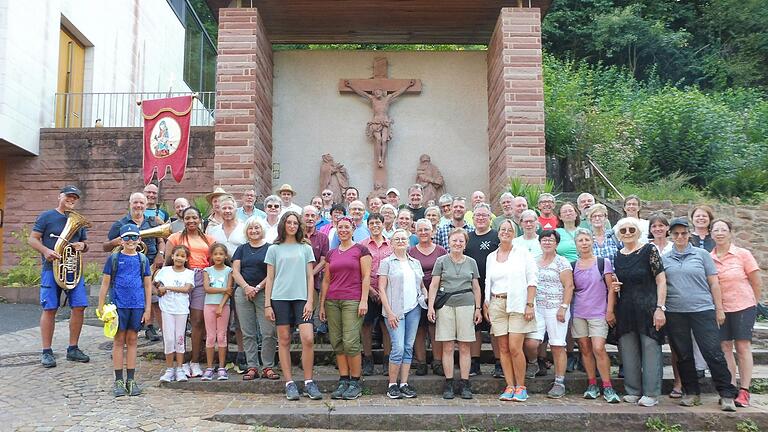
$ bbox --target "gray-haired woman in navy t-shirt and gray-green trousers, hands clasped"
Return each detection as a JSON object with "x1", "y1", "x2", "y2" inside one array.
[{"x1": 232, "y1": 216, "x2": 280, "y2": 381}]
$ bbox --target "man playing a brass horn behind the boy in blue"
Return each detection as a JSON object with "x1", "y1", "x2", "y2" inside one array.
[{"x1": 102, "y1": 192, "x2": 165, "y2": 341}]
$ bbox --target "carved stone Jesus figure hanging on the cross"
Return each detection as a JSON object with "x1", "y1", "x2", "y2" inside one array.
[{"x1": 344, "y1": 80, "x2": 416, "y2": 168}]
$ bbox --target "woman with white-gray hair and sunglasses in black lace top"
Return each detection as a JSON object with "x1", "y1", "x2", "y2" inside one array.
[{"x1": 611, "y1": 217, "x2": 667, "y2": 407}]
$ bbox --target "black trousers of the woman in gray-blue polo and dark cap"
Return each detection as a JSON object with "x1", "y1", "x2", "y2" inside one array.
[{"x1": 666, "y1": 310, "x2": 738, "y2": 398}]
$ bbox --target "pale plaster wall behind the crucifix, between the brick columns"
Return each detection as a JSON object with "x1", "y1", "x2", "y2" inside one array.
[{"x1": 272, "y1": 51, "x2": 488, "y2": 204}]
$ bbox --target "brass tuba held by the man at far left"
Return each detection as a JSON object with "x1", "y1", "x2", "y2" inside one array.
[{"x1": 51, "y1": 211, "x2": 91, "y2": 290}]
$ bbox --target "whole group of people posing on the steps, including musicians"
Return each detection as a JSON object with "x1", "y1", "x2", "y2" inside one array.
[{"x1": 30, "y1": 184, "x2": 761, "y2": 411}]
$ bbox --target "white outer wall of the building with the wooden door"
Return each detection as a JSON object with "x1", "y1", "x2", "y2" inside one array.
[{"x1": 0, "y1": 0, "x2": 189, "y2": 154}]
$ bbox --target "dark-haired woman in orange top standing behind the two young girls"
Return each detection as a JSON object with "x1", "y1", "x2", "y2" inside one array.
[{"x1": 165, "y1": 207, "x2": 216, "y2": 377}]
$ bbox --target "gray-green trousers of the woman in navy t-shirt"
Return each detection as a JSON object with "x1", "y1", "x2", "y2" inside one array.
[{"x1": 235, "y1": 288, "x2": 277, "y2": 368}]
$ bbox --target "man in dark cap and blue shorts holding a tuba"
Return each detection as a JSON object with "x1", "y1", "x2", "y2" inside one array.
[{"x1": 28, "y1": 185, "x2": 90, "y2": 368}]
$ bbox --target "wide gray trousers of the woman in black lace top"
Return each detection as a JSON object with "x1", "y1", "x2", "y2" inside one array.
[{"x1": 619, "y1": 332, "x2": 664, "y2": 397}]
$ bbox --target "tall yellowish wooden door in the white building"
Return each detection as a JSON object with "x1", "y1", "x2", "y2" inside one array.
[{"x1": 56, "y1": 27, "x2": 85, "y2": 127}]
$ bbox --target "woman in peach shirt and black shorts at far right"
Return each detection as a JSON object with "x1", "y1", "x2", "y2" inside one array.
[{"x1": 710, "y1": 219, "x2": 761, "y2": 407}]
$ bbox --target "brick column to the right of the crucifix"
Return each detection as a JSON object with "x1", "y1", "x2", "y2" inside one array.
[{"x1": 488, "y1": 8, "x2": 546, "y2": 205}]
